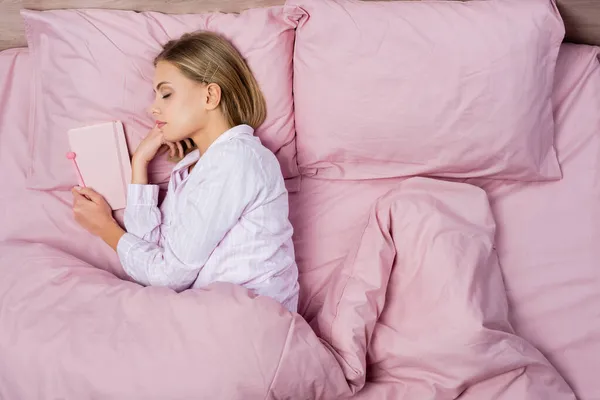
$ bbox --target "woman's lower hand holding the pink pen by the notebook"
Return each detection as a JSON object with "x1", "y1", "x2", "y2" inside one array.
[{"x1": 71, "y1": 187, "x2": 117, "y2": 236}]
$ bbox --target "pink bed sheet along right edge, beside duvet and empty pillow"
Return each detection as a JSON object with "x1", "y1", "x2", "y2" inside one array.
[{"x1": 472, "y1": 44, "x2": 600, "y2": 400}]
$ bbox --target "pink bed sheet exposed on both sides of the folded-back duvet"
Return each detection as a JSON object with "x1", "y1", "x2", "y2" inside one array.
[{"x1": 290, "y1": 44, "x2": 600, "y2": 400}]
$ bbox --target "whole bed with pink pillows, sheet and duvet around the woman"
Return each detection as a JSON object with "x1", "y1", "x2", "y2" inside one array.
[{"x1": 0, "y1": 0, "x2": 600, "y2": 400}]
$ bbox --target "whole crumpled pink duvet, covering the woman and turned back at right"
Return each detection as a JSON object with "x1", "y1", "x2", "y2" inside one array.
[{"x1": 0, "y1": 178, "x2": 575, "y2": 400}]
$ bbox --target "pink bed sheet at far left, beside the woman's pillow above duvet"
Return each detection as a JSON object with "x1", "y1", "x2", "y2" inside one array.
[{"x1": 0, "y1": 49, "x2": 122, "y2": 272}]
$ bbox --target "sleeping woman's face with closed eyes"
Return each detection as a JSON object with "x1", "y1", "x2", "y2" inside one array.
[{"x1": 150, "y1": 61, "x2": 207, "y2": 142}]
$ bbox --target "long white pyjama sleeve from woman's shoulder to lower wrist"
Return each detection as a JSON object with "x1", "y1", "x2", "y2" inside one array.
[{"x1": 117, "y1": 146, "x2": 266, "y2": 291}]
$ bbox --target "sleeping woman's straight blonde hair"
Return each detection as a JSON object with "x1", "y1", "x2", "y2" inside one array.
[{"x1": 154, "y1": 31, "x2": 267, "y2": 129}]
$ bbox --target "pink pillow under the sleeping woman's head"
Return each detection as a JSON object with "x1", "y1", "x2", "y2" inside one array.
[{"x1": 21, "y1": 7, "x2": 298, "y2": 189}]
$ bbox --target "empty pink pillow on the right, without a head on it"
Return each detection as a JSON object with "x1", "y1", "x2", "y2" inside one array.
[{"x1": 289, "y1": 0, "x2": 564, "y2": 180}]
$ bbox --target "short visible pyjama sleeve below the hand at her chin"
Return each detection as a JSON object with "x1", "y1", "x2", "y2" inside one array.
[{"x1": 123, "y1": 184, "x2": 162, "y2": 243}]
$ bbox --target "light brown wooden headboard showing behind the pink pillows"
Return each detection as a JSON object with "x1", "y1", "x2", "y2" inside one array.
[{"x1": 0, "y1": 0, "x2": 600, "y2": 50}]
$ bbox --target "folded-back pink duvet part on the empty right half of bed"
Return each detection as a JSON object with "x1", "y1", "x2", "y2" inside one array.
[{"x1": 315, "y1": 178, "x2": 575, "y2": 400}]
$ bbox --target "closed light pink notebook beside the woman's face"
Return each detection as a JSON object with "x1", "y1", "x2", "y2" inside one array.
[{"x1": 68, "y1": 121, "x2": 131, "y2": 210}]
